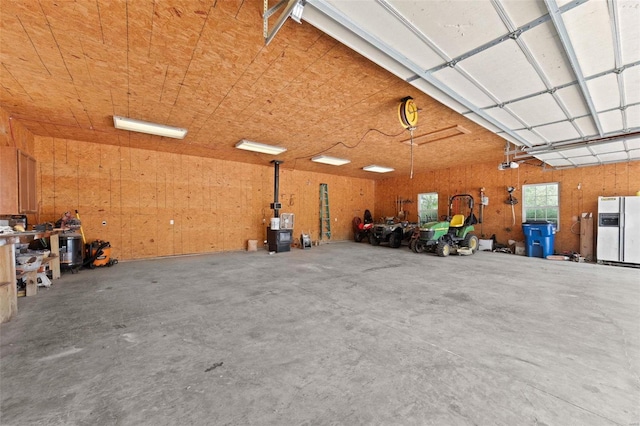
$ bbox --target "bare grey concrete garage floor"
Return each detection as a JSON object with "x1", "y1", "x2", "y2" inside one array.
[{"x1": 0, "y1": 242, "x2": 640, "y2": 426}]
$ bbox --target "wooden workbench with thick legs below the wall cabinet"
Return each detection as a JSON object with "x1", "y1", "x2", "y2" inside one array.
[{"x1": 0, "y1": 229, "x2": 62, "y2": 323}]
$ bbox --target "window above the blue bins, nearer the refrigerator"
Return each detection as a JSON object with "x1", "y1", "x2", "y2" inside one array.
[{"x1": 522, "y1": 182, "x2": 560, "y2": 230}]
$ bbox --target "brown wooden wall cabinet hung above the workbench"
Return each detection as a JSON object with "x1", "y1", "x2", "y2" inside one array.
[{"x1": 0, "y1": 146, "x2": 38, "y2": 214}]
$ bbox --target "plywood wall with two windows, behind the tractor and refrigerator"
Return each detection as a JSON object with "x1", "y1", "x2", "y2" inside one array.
[{"x1": 374, "y1": 161, "x2": 640, "y2": 252}]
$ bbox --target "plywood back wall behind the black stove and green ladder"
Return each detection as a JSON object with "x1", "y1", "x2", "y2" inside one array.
[{"x1": 35, "y1": 136, "x2": 375, "y2": 260}]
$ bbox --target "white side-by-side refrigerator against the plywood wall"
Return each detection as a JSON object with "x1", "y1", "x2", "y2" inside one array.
[{"x1": 596, "y1": 196, "x2": 640, "y2": 264}]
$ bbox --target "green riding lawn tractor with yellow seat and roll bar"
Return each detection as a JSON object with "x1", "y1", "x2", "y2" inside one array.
[{"x1": 409, "y1": 194, "x2": 478, "y2": 257}]
